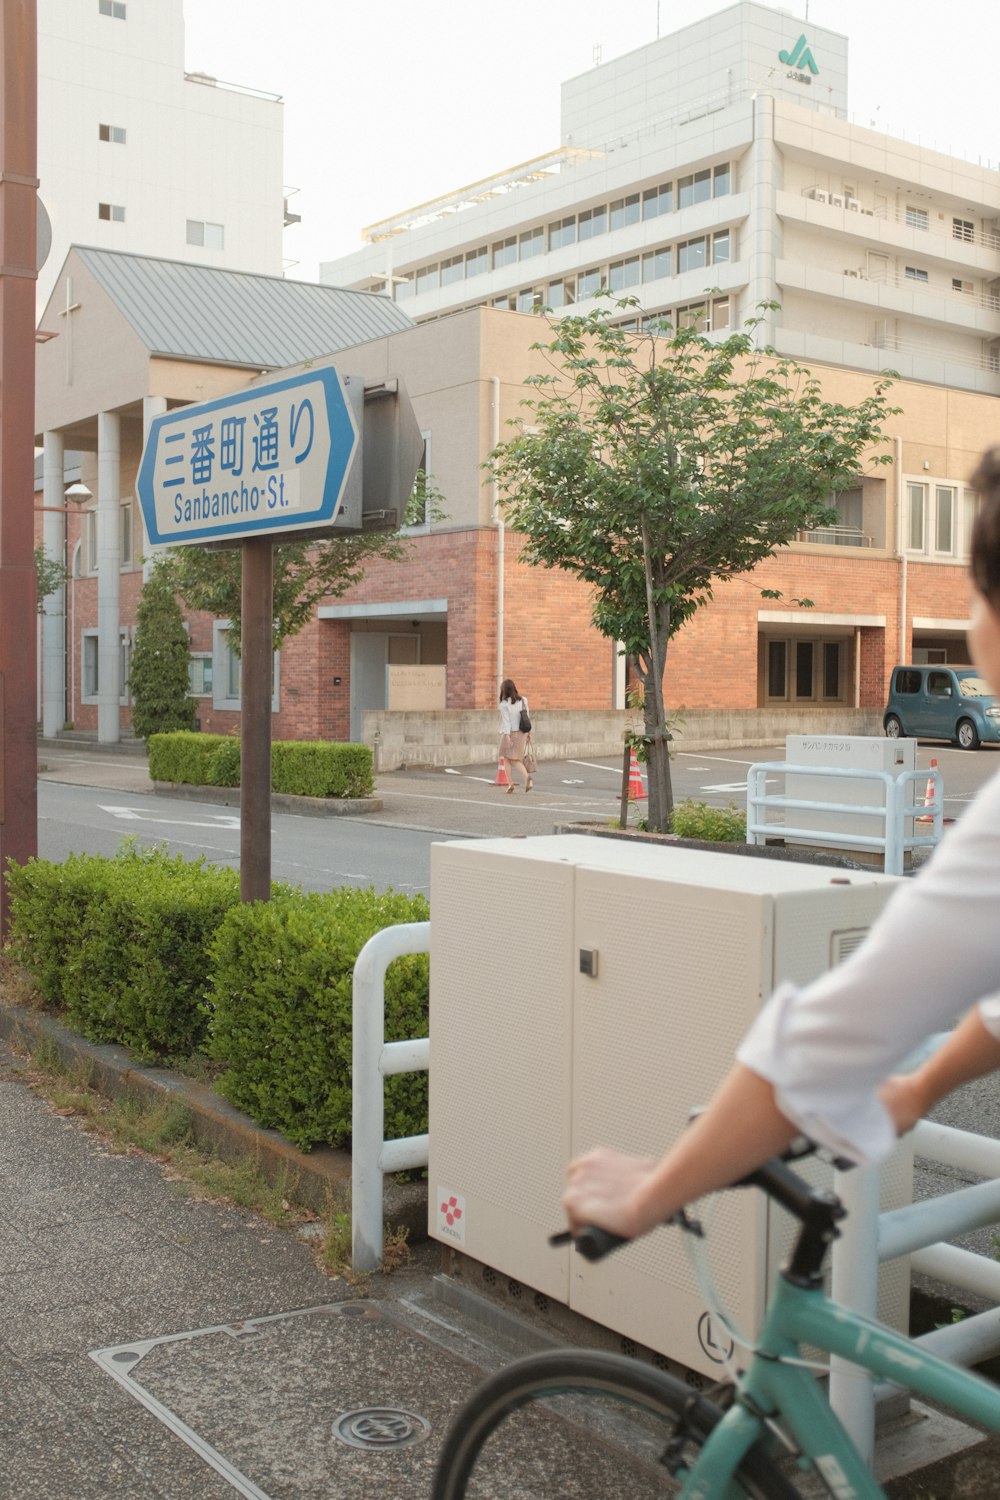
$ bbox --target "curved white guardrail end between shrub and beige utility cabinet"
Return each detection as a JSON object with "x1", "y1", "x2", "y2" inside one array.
[{"x1": 351, "y1": 923, "x2": 430, "y2": 1271}]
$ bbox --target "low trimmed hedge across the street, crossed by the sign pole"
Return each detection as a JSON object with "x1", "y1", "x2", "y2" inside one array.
[{"x1": 148, "y1": 731, "x2": 375, "y2": 797}]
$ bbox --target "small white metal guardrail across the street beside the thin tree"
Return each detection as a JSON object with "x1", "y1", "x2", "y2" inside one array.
[{"x1": 747, "y1": 761, "x2": 945, "y2": 875}]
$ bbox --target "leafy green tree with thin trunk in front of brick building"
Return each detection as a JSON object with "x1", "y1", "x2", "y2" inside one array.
[{"x1": 487, "y1": 300, "x2": 895, "y2": 831}]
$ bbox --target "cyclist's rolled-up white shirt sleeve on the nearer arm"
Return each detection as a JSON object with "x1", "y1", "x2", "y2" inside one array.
[{"x1": 738, "y1": 773, "x2": 1000, "y2": 1161}]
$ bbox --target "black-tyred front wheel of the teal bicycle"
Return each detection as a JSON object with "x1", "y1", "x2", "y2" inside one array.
[{"x1": 432, "y1": 1350, "x2": 799, "y2": 1500}]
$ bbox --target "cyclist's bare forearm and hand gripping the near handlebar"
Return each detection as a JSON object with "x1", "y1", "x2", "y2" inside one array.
[{"x1": 562, "y1": 1064, "x2": 799, "y2": 1239}]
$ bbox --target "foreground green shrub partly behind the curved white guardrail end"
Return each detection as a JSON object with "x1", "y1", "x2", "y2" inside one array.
[{"x1": 207, "y1": 887, "x2": 429, "y2": 1149}]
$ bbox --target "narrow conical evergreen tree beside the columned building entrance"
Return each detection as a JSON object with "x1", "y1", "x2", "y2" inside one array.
[{"x1": 129, "y1": 563, "x2": 196, "y2": 740}]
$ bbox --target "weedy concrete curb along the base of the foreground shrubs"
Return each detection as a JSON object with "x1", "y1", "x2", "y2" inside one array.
[{"x1": 0, "y1": 1002, "x2": 427, "y2": 1244}]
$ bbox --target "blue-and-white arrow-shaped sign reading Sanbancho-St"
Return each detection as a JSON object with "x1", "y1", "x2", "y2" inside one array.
[{"x1": 135, "y1": 368, "x2": 358, "y2": 548}]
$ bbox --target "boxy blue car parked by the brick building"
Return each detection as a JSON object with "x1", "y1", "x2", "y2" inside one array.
[{"x1": 882, "y1": 666, "x2": 1000, "y2": 750}]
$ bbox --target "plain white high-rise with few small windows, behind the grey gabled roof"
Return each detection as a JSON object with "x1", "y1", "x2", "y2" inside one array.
[{"x1": 37, "y1": 0, "x2": 283, "y2": 312}]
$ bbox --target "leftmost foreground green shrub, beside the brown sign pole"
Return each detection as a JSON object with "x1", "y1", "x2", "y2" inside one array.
[{"x1": 7, "y1": 843, "x2": 240, "y2": 1059}]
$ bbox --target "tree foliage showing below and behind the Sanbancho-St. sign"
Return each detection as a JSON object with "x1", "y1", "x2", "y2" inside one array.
[{"x1": 166, "y1": 471, "x2": 444, "y2": 656}]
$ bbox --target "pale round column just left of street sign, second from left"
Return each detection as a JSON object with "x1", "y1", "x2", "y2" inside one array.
[{"x1": 97, "y1": 411, "x2": 121, "y2": 744}]
